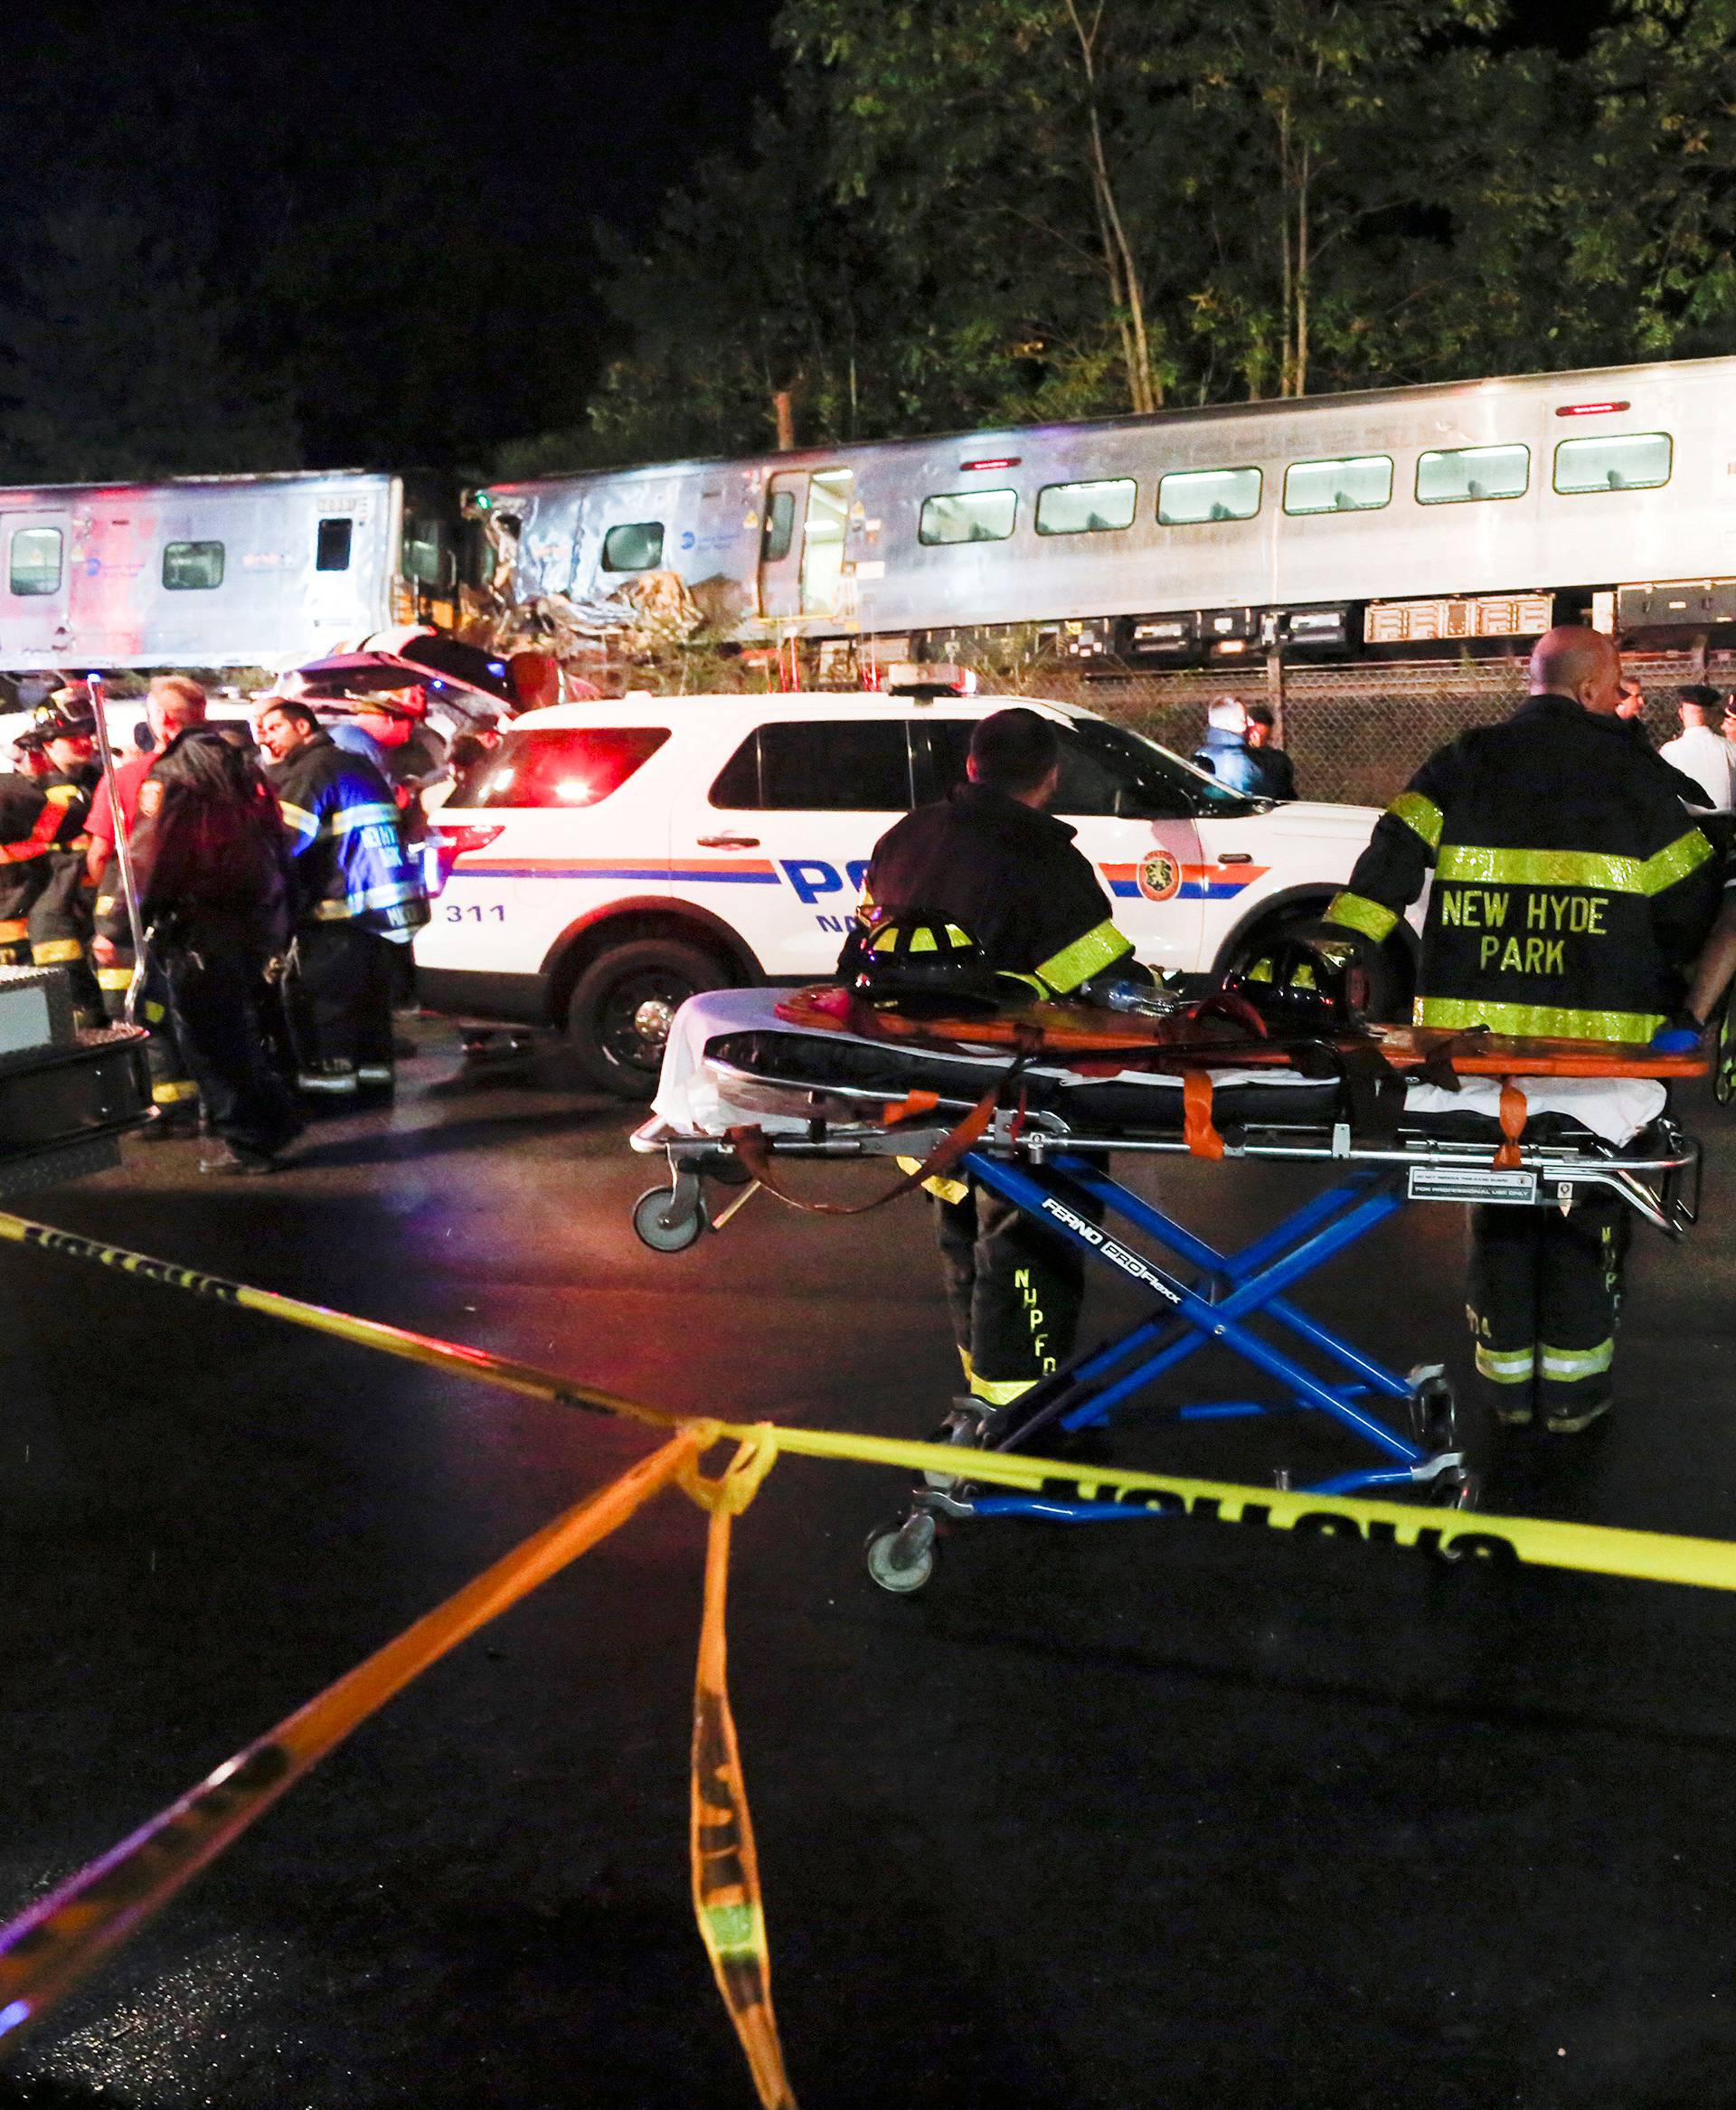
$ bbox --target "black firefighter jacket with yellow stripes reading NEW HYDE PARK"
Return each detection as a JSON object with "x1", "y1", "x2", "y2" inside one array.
[{"x1": 1326, "y1": 695, "x2": 1719, "y2": 1040}]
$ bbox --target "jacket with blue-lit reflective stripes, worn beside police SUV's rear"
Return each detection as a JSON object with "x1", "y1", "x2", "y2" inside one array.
[{"x1": 266, "y1": 733, "x2": 429, "y2": 939}]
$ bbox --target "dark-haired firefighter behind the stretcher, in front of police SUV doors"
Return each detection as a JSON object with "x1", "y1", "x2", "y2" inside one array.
[{"x1": 840, "y1": 707, "x2": 1149, "y2": 1412}]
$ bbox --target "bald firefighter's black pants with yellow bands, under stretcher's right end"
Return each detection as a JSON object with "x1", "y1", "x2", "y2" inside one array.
[{"x1": 1466, "y1": 1197, "x2": 1628, "y2": 1422}]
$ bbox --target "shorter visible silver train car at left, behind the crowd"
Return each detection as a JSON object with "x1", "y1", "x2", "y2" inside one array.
[{"x1": 0, "y1": 470, "x2": 460, "y2": 677}]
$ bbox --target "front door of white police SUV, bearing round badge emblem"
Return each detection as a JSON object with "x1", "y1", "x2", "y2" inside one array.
[{"x1": 918, "y1": 714, "x2": 1206, "y2": 973}]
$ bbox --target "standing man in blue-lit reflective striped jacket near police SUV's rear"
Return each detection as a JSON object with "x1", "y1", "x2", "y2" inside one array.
[{"x1": 259, "y1": 698, "x2": 429, "y2": 1099}]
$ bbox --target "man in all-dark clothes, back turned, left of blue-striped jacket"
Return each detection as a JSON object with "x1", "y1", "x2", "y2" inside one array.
[{"x1": 95, "y1": 724, "x2": 302, "y2": 1175}]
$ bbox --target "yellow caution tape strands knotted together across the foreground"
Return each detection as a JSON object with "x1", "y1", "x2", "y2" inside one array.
[{"x1": 16, "y1": 1211, "x2": 1736, "y2": 2110}]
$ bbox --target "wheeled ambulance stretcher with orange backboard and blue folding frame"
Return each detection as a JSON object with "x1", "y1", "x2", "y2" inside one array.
[{"x1": 633, "y1": 989, "x2": 1704, "y2": 1591}]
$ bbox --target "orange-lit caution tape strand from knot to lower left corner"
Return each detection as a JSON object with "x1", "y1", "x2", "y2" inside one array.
[{"x1": 0, "y1": 1422, "x2": 709, "y2": 2048}]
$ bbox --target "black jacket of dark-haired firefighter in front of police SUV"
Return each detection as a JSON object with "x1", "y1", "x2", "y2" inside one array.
[{"x1": 863, "y1": 783, "x2": 1133, "y2": 996}]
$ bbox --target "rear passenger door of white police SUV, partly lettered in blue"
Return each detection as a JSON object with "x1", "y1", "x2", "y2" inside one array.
[{"x1": 687, "y1": 698, "x2": 911, "y2": 981}]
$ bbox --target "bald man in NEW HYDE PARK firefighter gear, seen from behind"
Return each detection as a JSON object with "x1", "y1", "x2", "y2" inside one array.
[{"x1": 1326, "y1": 625, "x2": 1717, "y2": 1434}]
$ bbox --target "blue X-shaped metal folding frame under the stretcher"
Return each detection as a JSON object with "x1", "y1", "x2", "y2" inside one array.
[{"x1": 945, "y1": 1150, "x2": 1462, "y2": 1523}]
